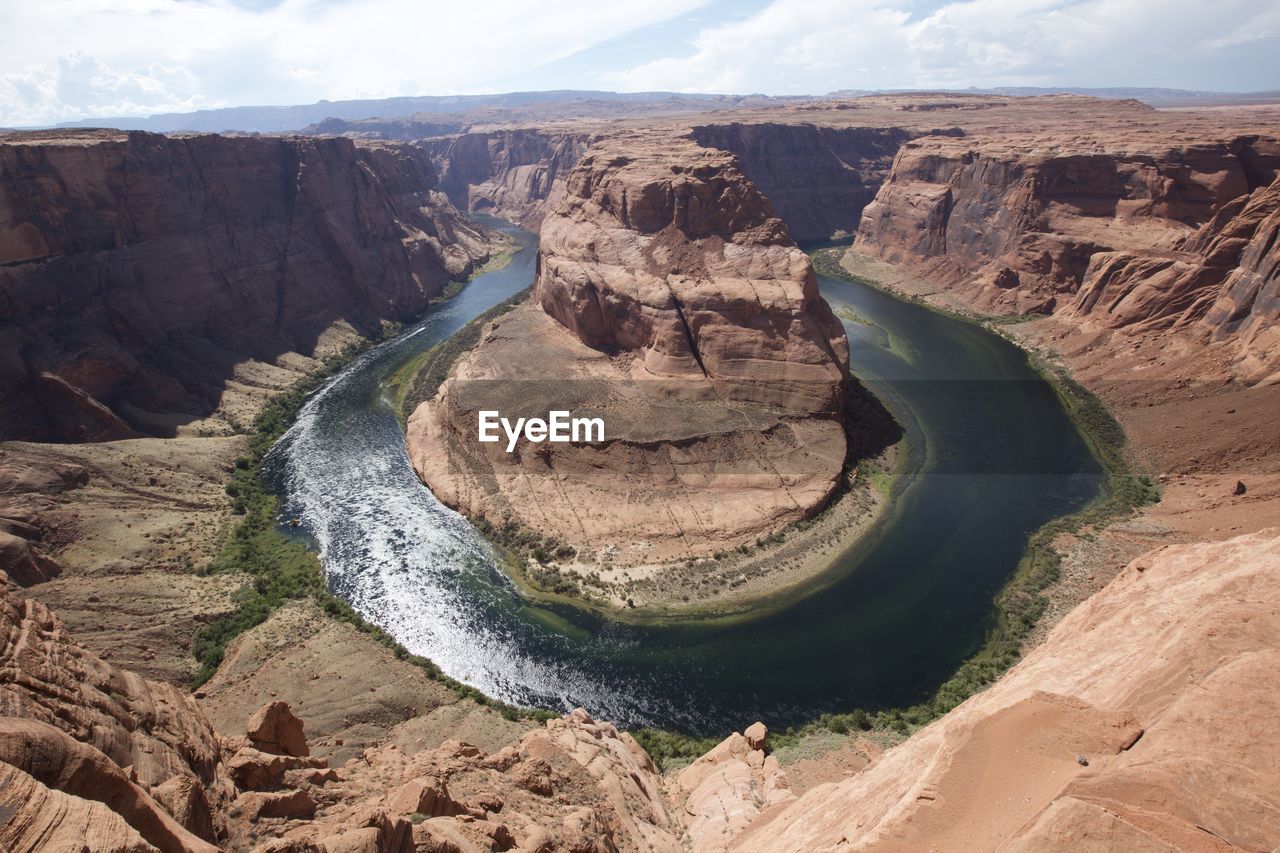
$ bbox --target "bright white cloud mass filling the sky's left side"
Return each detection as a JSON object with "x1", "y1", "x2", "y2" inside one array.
[{"x1": 0, "y1": 0, "x2": 707, "y2": 124}]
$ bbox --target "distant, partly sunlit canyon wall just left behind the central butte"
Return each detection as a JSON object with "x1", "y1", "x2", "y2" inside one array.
[{"x1": 417, "y1": 129, "x2": 594, "y2": 231}]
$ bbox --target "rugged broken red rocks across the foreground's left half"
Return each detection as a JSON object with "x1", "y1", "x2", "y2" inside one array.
[{"x1": 0, "y1": 579, "x2": 701, "y2": 853}]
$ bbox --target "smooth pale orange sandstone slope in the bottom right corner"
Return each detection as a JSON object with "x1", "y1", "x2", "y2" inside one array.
[{"x1": 735, "y1": 529, "x2": 1280, "y2": 850}]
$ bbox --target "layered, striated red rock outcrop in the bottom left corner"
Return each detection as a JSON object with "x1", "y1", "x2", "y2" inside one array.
[{"x1": 0, "y1": 576, "x2": 232, "y2": 850}]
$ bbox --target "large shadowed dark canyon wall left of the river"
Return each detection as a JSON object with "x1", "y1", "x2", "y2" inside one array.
[{"x1": 0, "y1": 131, "x2": 488, "y2": 441}]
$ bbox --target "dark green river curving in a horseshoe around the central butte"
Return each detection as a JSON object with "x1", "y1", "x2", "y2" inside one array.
[{"x1": 268, "y1": 222, "x2": 1102, "y2": 734}]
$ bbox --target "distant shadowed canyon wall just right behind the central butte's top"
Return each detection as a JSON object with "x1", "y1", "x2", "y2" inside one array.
[{"x1": 691, "y1": 122, "x2": 931, "y2": 242}]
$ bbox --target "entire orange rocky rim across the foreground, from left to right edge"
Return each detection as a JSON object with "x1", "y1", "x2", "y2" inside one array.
[{"x1": 0, "y1": 529, "x2": 1280, "y2": 853}]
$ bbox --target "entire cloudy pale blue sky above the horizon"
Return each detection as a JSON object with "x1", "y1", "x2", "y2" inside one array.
[{"x1": 0, "y1": 0, "x2": 1280, "y2": 127}]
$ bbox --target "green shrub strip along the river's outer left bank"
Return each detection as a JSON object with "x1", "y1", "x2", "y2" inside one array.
[{"x1": 191, "y1": 308, "x2": 559, "y2": 720}]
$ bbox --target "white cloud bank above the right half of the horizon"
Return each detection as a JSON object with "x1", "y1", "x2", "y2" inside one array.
[{"x1": 604, "y1": 0, "x2": 1280, "y2": 93}]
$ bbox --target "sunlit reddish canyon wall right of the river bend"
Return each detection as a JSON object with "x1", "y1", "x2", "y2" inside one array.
[{"x1": 854, "y1": 128, "x2": 1280, "y2": 374}]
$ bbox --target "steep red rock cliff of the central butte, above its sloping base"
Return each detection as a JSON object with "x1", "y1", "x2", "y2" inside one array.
[{"x1": 534, "y1": 141, "x2": 849, "y2": 414}]
